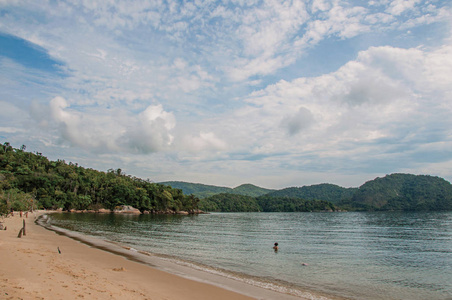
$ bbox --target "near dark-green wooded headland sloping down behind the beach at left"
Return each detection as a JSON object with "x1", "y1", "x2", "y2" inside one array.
[{"x1": 0, "y1": 143, "x2": 199, "y2": 214}]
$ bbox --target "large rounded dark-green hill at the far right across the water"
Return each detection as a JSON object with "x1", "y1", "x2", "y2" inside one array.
[{"x1": 342, "y1": 174, "x2": 452, "y2": 211}]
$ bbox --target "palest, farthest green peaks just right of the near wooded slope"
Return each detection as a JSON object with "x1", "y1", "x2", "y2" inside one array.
[{"x1": 160, "y1": 181, "x2": 274, "y2": 199}]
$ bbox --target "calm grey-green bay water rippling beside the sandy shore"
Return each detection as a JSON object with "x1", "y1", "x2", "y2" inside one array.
[{"x1": 47, "y1": 212, "x2": 452, "y2": 299}]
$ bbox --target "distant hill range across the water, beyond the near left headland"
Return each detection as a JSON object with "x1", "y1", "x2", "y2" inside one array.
[{"x1": 161, "y1": 174, "x2": 452, "y2": 211}]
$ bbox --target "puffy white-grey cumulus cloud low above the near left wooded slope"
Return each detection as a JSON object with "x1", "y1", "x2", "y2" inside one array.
[{"x1": 32, "y1": 97, "x2": 176, "y2": 153}]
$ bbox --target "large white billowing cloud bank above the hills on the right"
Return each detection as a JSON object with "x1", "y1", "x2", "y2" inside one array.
[{"x1": 223, "y1": 43, "x2": 452, "y2": 169}]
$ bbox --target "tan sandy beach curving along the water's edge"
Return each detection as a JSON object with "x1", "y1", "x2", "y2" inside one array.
[{"x1": 0, "y1": 212, "x2": 308, "y2": 300}]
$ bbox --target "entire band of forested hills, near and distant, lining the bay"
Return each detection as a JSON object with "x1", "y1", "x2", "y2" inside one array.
[{"x1": 0, "y1": 143, "x2": 452, "y2": 214}]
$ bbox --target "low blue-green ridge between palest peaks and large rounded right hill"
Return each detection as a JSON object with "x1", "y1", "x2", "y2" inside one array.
[{"x1": 266, "y1": 183, "x2": 358, "y2": 204}]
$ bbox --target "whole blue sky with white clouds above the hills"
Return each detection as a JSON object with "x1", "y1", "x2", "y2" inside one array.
[{"x1": 0, "y1": 0, "x2": 452, "y2": 189}]
